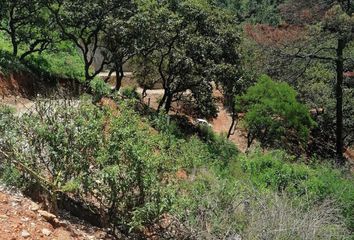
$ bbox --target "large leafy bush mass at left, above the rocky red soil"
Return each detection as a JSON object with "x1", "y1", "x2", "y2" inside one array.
[{"x1": 0, "y1": 100, "x2": 230, "y2": 233}]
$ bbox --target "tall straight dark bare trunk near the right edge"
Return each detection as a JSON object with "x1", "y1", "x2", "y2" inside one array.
[{"x1": 336, "y1": 39, "x2": 346, "y2": 165}]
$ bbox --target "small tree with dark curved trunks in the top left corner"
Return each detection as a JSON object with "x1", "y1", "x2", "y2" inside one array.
[{"x1": 0, "y1": 0, "x2": 55, "y2": 60}]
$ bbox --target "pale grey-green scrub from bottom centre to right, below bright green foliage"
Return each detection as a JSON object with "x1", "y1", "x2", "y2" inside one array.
[{"x1": 172, "y1": 169, "x2": 350, "y2": 240}]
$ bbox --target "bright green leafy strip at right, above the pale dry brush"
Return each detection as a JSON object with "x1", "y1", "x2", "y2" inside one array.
[{"x1": 242, "y1": 152, "x2": 354, "y2": 229}]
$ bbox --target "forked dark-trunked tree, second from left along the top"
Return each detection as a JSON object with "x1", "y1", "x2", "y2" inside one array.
[{"x1": 47, "y1": 0, "x2": 130, "y2": 82}]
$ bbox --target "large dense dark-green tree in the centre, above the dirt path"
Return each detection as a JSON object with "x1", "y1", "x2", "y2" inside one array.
[{"x1": 137, "y1": 0, "x2": 239, "y2": 117}]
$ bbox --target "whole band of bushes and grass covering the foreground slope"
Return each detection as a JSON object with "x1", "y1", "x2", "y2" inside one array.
[{"x1": 0, "y1": 99, "x2": 354, "y2": 239}]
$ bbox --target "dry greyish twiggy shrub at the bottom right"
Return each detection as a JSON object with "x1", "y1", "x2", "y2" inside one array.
[{"x1": 243, "y1": 194, "x2": 350, "y2": 240}]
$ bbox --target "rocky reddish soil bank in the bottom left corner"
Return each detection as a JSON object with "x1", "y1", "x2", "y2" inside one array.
[{"x1": 0, "y1": 187, "x2": 112, "y2": 240}]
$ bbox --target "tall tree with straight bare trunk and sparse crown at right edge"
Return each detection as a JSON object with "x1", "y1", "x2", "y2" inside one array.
[{"x1": 245, "y1": 0, "x2": 354, "y2": 165}]
